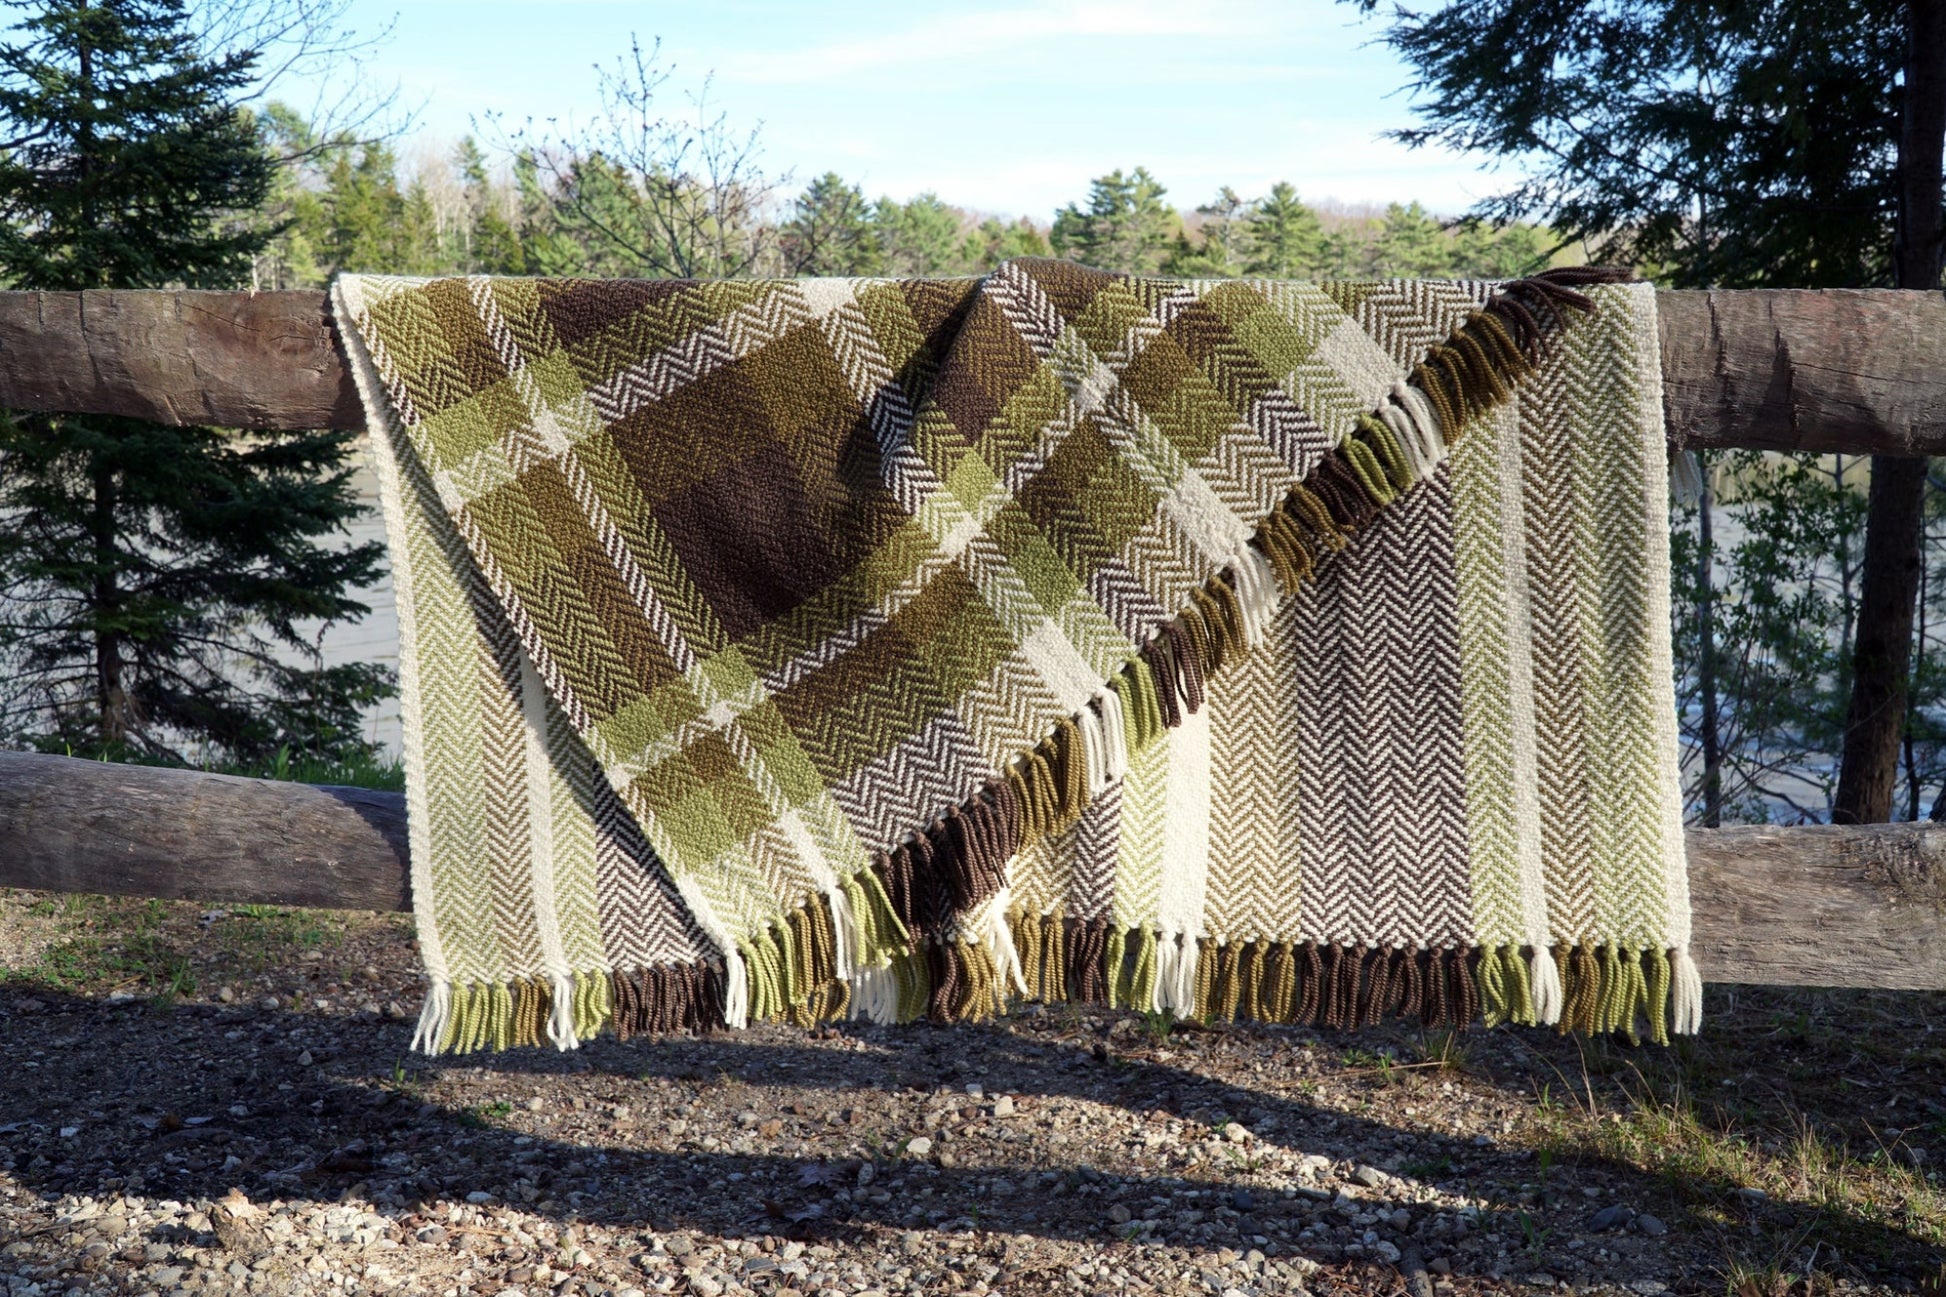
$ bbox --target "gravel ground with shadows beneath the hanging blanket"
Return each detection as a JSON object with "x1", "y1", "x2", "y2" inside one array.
[{"x1": 0, "y1": 894, "x2": 1946, "y2": 1297}]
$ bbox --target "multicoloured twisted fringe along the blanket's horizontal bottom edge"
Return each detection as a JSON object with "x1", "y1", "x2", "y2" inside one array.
[{"x1": 413, "y1": 930, "x2": 1703, "y2": 1054}]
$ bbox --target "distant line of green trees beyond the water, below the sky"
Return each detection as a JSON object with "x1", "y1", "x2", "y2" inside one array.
[{"x1": 255, "y1": 107, "x2": 1555, "y2": 288}]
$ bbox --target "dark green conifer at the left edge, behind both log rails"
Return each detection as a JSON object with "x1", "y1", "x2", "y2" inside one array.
[{"x1": 0, "y1": 0, "x2": 389, "y2": 760}]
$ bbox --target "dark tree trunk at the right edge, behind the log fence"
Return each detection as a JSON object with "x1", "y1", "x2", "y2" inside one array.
[{"x1": 1831, "y1": 0, "x2": 1946, "y2": 824}]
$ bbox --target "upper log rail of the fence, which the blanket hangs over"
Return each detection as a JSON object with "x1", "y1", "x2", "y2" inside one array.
[{"x1": 11, "y1": 288, "x2": 1946, "y2": 454}]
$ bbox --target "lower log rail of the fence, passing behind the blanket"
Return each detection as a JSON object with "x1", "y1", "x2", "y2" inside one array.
[{"x1": 0, "y1": 752, "x2": 1946, "y2": 991}]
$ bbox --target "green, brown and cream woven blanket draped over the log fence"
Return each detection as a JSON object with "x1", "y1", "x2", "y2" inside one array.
[{"x1": 333, "y1": 261, "x2": 1701, "y2": 1052}]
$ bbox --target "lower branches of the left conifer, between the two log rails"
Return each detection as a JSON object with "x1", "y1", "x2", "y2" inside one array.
[{"x1": 0, "y1": 415, "x2": 391, "y2": 760}]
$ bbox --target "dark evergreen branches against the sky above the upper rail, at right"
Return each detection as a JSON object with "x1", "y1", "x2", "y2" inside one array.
[{"x1": 1360, "y1": 0, "x2": 1905, "y2": 288}]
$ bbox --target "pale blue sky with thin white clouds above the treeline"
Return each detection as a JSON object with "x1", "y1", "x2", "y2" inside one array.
[{"x1": 303, "y1": 0, "x2": 1506, "y2": 220}]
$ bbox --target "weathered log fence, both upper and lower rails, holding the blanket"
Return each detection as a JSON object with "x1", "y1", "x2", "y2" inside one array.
[{"x1": 0, "y1": 290, "x2": 1946, "y2": 989}]
